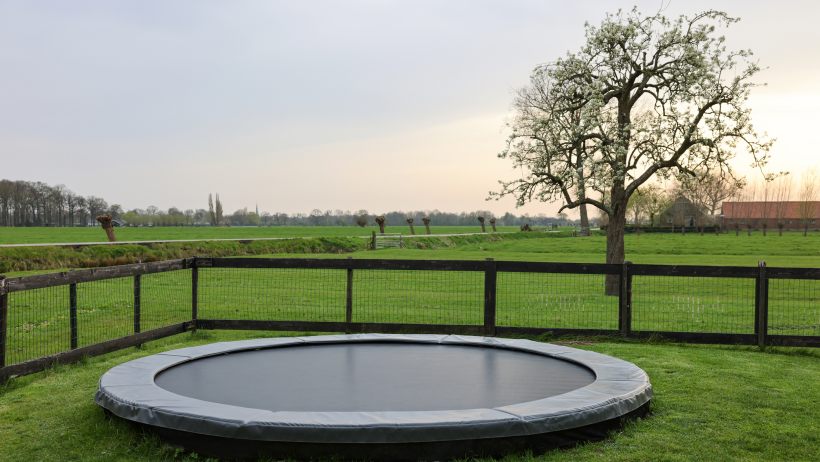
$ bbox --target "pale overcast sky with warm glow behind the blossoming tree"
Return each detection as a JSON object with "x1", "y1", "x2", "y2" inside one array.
[{"x1": 0, "y1": 0, "x2": 820, "y2": 214}]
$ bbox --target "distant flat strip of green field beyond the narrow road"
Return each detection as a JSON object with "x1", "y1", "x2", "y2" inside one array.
[{"x1": 0, "y1": 222, "x2": 518, "y2": 245}]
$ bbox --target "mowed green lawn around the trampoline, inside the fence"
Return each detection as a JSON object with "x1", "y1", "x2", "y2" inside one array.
[{"x1": 0, "y1": 331, "x2": 820, "y2": 462}]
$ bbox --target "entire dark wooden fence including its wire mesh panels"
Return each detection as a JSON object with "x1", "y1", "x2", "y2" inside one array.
[{"x1": 0, "y1": 257, "x2": 820, "y2": 381}]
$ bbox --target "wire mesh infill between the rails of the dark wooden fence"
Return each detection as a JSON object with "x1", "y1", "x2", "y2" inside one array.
[{"x1": 0, "y1": 259, "x2": 820, "y2": 376}]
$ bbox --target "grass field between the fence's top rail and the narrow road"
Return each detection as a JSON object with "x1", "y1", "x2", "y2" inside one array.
[{"x1": 0, "y1": 227, "x2": 820, "y2": 274}]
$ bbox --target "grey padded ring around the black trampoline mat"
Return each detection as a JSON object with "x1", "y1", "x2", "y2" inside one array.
[{"x1": 95, "y1": 334, "x2": 652, "y2": 443}]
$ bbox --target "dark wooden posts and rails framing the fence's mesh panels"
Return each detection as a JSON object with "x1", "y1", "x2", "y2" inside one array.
[{"x1": 0, "y1": 258, "x2": 820, "y2": 381}]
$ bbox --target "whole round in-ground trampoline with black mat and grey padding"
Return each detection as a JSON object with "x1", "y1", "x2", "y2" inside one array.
[{"x1": 96, "y1": 334, "x2": 652, "y2": 460}]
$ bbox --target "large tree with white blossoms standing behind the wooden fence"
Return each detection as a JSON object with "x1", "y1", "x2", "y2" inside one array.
[{"x1": 498, "y1": 9, "x2": 771, "y2": 295}]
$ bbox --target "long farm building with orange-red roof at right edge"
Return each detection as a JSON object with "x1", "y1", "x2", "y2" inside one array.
[{"x1": 720, "y1": 201, "x2": 820, "y2": 229}]
